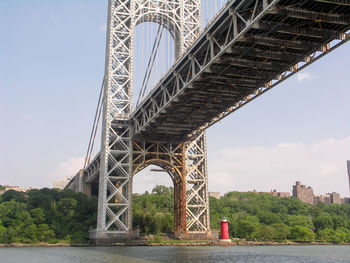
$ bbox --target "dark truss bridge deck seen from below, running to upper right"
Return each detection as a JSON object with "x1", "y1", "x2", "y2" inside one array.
[{"x1": 130, "y1": 0, "x2": 350, "y2": 142}]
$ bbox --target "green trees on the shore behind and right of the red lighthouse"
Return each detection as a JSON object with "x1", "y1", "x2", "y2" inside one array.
[{"x1": 210, "y1": 192, "x2": 350, "y2": 243}]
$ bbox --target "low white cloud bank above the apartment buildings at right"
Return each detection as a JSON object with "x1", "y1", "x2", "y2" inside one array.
[{"x1": 208, "y1": 136, "x2": 350, "y2": 196}]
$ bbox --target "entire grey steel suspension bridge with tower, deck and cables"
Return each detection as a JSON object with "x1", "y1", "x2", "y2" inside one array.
[{"x1": 66, "y1": 0, "x2": 350, "y2": 243}]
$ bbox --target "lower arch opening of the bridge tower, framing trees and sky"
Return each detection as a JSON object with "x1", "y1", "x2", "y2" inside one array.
[{"x1": 132, "y1": 164, "x2": 174, "y2": 235}]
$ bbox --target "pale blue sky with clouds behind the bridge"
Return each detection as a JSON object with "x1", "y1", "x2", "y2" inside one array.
[{"x1": 0, "y1": 0, "x2": 350, "y2": 196}]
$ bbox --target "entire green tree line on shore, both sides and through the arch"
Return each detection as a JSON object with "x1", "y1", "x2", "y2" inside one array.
[{"x1": 0, "y1": 185, "x2": 350, "y2": 243}]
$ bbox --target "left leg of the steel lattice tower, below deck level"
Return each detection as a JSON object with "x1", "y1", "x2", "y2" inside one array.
[{"x1": 94, "y1": 120, "x2": 134, "y2": 244}]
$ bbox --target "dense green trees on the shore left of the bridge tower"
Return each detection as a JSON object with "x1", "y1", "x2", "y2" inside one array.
[{"x1": 0, "y1": 188, "x2": 97, "y2": 243}]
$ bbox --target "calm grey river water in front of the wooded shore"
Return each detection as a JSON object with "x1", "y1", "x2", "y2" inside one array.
[{"x1": 0, "y1": 246, "x2": 350, "y2": 263}]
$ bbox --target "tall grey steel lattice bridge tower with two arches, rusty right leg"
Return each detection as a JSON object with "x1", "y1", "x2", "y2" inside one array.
[{"x1": 90, "y1": 0, "x2": 210, "y2": 243}]
